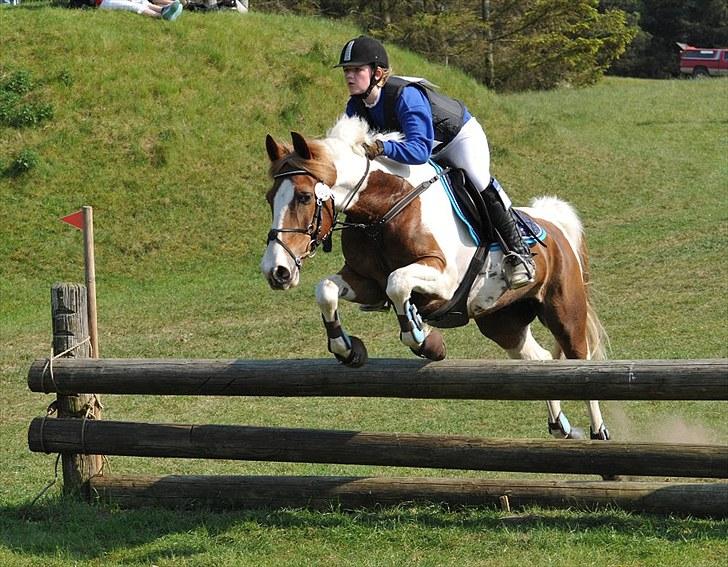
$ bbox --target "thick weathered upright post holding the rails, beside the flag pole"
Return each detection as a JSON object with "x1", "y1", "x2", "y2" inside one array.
[{"x1": 51, "y1": 283, "x2": 102, "y2": 494}]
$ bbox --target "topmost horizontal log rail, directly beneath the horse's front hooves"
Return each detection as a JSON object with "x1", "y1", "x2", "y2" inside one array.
[{"x1": 28, "y1": 358, "x2": 728, "y2": 400}]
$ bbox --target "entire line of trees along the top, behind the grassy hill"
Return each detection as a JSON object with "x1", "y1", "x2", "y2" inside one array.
[{"x1": 255, "y1": 0, "x2": 728, "y2": 90}]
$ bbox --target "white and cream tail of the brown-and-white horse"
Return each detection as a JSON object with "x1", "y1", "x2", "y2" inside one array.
[{"x1": 531, "y1": 197, "x2": 609, "y2": 360}]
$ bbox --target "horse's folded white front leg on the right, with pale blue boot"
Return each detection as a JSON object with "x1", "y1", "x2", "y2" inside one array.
[{"x1": 387, "y1": 259, "x2": 454, "y2": 360}]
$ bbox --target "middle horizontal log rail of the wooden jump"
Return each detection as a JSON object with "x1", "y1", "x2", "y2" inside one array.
[{"x1": 28, "y1": 418, "x2": 728, "y2": 478}]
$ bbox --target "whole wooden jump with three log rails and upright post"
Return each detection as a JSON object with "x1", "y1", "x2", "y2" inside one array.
[{"x1": 28, "y1": 284, "x2": 728, "y2": 517}]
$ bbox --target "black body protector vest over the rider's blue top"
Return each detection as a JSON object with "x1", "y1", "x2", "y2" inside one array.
[{"x1": 352, "y1": 77, "x2": 465, "y2": 154}]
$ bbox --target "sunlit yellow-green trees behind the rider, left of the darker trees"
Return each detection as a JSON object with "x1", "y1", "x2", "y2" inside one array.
[{"x1": 259, "y1": 0, "x2": 637, "y2": 90}]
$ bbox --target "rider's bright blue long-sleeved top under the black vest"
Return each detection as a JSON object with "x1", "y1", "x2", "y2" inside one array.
[{"x1": 346, "y1": 85, "x2": 435, "y2": 165}]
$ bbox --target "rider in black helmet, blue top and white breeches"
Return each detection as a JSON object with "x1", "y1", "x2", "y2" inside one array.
[{"x1": 335, "y1": 35, "x2": 535, "y2": 289}]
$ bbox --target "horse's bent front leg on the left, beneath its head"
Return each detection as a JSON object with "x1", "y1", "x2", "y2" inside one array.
[{"x1": 316, "y1": 267, "x2": 384, "y2": 368}]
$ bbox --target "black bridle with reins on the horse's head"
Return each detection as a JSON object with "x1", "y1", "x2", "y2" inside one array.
[{"x1": 267, "y1": 160, "x2": 370, "y2": 268}]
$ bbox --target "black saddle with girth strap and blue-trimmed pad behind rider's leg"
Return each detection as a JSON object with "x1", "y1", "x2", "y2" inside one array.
[{"x1": 422, "y1": 169, "x2": 546, "y2": 328}]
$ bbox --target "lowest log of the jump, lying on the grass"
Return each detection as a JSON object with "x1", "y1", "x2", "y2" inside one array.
[{"x1": 89, "y1": 475, "x2": 728, "y2": 518}]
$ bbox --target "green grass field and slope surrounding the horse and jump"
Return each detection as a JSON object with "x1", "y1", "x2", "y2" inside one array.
[{"x1": 0, "y1": 8, "x2": 728, "y2": 566}]
